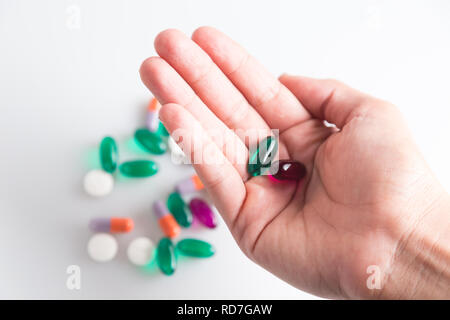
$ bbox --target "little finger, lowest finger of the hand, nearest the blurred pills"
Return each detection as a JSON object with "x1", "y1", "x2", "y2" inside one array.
[{"x1": 160, "y1": 103, "x2": 246, "y2": 226}]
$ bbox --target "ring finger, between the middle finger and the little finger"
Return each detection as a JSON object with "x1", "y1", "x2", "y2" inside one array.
[{"x1": 140, "y1": 57, "x2": 248, "y2": 179}]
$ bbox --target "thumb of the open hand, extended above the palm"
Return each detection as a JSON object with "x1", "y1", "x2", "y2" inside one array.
[{"x1": 280, "y1": 75, "x2": 373, "y2": 128}]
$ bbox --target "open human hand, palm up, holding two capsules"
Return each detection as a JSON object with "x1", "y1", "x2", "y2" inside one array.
[{"x1": 140, "y1": 27, "x2": 450, "y2": 298}]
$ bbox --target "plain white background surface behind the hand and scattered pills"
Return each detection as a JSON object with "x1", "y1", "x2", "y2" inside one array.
[{"x1": 0, "y1": 0, "x2": 450, "y2": 299}]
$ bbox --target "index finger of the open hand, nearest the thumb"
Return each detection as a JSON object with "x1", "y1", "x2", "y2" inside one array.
[{"x1": 192, "y1": 27, "x2": 310, "y2": 131}]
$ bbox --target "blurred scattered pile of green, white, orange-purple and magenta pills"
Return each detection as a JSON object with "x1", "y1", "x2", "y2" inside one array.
[{"x1": 83, "y1": 98, "x2": 217, "y2": 275}]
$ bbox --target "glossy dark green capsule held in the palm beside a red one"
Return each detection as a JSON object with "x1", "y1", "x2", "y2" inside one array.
[{"x1": 247, "y1": 136, "x2": 278, "y2": 177}]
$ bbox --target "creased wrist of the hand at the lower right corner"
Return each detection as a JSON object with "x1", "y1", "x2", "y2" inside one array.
[{"x1": 379, "y1": 193, "x2": 450, "y2": 299}]
